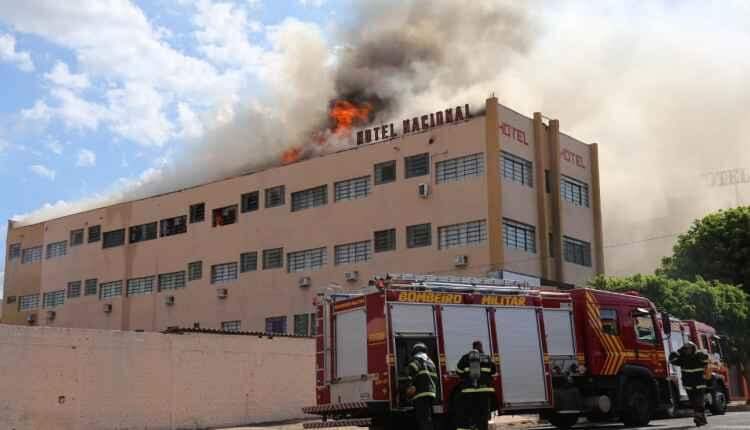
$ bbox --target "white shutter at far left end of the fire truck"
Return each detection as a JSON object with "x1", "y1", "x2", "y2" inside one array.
[{"x1": 336, "y1": 309, "x2": 367, "y2": 378}]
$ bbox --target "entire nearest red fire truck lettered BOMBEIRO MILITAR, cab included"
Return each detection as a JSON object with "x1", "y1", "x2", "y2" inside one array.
[{"x1": 303, "y1": 275, "x2": 672, "y2": 429}]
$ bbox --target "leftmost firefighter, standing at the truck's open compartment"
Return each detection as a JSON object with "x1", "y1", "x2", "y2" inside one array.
[{"x1": 406, "y1": 342, "x2": 438, "y2": 430}]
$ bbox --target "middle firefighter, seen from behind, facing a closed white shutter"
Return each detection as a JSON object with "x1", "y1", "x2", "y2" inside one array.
[{"x1": 456, "y1": 340, "x2": 497, "y2": 430}]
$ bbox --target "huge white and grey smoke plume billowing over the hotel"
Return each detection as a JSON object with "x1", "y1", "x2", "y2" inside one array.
[{"x1": 11, "y1": 0, "x2": 750, "y2": 273}]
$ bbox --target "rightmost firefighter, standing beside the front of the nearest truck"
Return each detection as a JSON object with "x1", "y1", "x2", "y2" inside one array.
[{"x1": 669, "y1": 342, "x2": 708, "y2": 427}]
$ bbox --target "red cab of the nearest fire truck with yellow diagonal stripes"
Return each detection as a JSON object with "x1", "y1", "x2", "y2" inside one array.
[{"x1": 541, "y1": 288, "x2": 674, "y2": 428}]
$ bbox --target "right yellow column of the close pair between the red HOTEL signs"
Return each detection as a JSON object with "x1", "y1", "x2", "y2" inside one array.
[{"x1": 547, "y1": 119, "x2": 565, "y2": 282}]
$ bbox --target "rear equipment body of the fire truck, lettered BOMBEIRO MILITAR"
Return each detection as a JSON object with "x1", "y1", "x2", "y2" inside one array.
[{"x1": 303, "y1": 274, "x2": 556, "y2": 429}]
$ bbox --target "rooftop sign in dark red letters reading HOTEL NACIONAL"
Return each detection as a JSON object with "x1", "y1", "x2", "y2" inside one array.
[{"x1": 357, "y1": 104, "x2": 471, "y2": 145}]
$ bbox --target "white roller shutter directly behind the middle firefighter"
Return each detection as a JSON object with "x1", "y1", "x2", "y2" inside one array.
[{"x1": 442, "y1": 306, "x2": 490, "y2": 372}]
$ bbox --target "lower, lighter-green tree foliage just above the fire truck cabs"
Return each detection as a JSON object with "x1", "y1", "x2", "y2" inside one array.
[{"x1": 589, "y1": 275, "x2": 750, "y2": 400}]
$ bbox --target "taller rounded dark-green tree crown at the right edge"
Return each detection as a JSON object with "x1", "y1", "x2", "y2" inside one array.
[{"x1": 657, "y1": 206, "x2": 750, "y2": 293}]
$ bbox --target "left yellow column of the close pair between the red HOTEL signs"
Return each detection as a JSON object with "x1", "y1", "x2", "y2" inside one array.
[{"x1": 534, "y1": 112, "x2": 550, "y2": 279}]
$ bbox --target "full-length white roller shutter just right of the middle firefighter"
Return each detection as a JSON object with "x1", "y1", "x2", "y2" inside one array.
[{"x1": 495, "y1": 308, "x2": 547, "y2": 407}]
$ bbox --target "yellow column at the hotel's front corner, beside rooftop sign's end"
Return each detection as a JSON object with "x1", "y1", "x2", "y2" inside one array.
[{"x1": 484, "y1": 97, "x2": 505, "y2": 270}]
